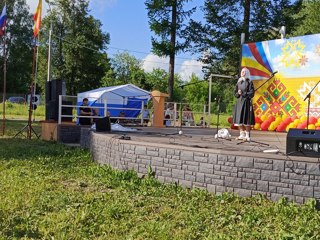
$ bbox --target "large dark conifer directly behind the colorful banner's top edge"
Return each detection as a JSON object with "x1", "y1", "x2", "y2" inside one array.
[{"x1": 188, "y1": 0, "x2": 298, "y2": 75}]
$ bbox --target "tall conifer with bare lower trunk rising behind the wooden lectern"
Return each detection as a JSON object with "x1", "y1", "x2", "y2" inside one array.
[{"x1": 145, "y1": 0, "x2": 196, "y2": 101}]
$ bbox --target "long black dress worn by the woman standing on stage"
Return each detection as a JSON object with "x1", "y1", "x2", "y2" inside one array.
[{"x1": 233, "y1": 79, "x2": 255, "y2": 126}]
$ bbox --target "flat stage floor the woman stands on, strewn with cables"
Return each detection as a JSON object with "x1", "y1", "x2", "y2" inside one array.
[{"x1": 105, "y1": 127, "x2": 317, "y2": 162}]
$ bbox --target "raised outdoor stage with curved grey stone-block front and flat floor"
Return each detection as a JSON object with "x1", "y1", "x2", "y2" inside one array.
[{"x1": 80, "y1": 127, "x2": 320, "y2": 203}]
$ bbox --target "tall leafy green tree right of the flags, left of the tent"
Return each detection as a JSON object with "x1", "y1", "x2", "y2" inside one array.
[{"x1": 39, "y1": 0, "x2": 110, "y2": 95}]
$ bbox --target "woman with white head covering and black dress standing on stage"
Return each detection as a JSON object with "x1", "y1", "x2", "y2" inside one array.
[{"x1": 233, "y1": 68, "x2": 255, "y2": 141}]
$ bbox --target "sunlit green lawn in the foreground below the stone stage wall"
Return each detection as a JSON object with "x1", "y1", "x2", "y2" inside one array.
[{"x1": 0, "y1": 138, "x2": 320, "y2": 239}]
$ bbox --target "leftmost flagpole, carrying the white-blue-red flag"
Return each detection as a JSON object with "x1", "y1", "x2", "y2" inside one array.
[{"x1": 2, "y1": 1, "x2": 7, "y2": 136}]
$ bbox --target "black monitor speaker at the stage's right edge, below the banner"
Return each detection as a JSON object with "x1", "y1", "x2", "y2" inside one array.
[{"x1": 286, "y1": 128, "x2": 320, "y2": 158}]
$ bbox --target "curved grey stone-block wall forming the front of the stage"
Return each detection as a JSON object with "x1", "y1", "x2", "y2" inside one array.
[{"x1": 81, "y1": 129, "x2": 320, "y2": 203}]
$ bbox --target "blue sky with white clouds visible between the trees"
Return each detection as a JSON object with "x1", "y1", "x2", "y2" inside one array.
[{"x1": 27, "y1": 0, "x2": 204, "y2": 81}]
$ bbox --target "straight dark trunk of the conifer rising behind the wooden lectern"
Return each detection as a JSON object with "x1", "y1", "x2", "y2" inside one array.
[{"x1": 168, "y1": 0, "x2": 177, "y2": 102}]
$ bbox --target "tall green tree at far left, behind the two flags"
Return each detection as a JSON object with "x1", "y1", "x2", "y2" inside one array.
[{"x1": 0, "y1": 0, "x2": 33, "y2": 94}]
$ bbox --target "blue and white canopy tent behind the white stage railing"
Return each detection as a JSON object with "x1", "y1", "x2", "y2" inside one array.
[{"x1": 77, "y1": 84, "x2": 150, "y2": 118}]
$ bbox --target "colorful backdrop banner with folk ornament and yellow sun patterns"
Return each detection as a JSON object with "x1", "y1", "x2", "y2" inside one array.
[{"x1": 241, "y1": 34, "x2": 320, "y2": 131}]
